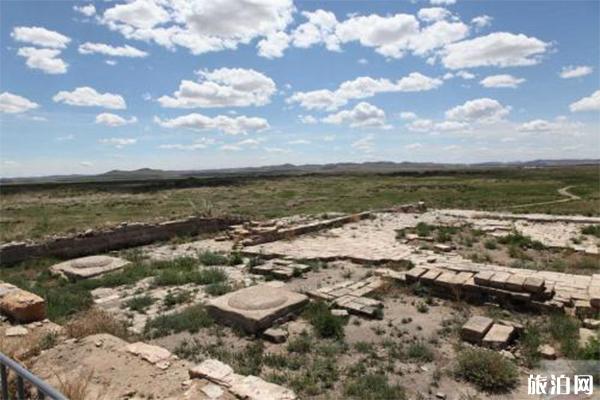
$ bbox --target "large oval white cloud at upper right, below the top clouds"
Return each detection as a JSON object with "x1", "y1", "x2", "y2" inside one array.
[{"x1": 442, "y1": 32, "x2": 550, "y2": 69}]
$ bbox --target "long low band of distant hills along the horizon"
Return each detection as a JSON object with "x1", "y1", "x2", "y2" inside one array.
[{"x1": 0, "y1": 159, "x2": 600, "y2": 185}]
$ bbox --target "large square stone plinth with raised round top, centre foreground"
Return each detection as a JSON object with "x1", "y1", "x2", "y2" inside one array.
[{"x1": 207, "y1": 284, "x2": 308, "y2": 333}]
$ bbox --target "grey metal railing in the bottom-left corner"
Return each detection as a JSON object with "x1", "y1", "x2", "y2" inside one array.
[{"x1": 0, "y1": 352, "x2": 68, "y2": 400}]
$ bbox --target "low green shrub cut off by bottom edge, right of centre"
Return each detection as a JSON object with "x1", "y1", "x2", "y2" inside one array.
[{"x1": 344, "y1": 373, "x2": 406, "y2": 400}]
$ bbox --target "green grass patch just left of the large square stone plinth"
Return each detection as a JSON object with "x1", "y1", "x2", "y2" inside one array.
[{"x1": 144, "y1": 304, "x2": 214, "y2": 338}]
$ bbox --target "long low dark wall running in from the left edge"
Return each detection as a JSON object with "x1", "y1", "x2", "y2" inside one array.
[{"x1": 0, "y1": 217, "x2": 241, "y2": 266}]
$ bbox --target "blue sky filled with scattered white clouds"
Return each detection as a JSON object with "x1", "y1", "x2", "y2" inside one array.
[{"x1": 0, "y1": 0, "x2": 600, "y2": 177}]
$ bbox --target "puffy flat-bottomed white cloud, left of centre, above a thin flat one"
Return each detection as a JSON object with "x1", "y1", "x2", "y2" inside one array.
[{"x1": 158, "y1": 68, "x2": 276, "y2": 108}]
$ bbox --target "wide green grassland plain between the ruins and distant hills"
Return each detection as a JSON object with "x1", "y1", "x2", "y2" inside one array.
[{"x1": 0, "y1": 166, "x2": 600, "y2": 242}]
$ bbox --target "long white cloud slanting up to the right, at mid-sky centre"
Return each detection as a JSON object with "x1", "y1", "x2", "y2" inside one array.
[{"x1": 286, "y1": 72, "x2": 443, "y2": 110}]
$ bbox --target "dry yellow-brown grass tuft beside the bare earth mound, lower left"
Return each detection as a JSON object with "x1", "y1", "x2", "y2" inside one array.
[{"x1": 65, "y1": 308, "x2": 129, "y2": 340}]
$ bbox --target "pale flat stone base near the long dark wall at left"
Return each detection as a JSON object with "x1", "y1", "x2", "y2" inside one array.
[{"x1": 50, "y1": 256, "x2": 130, "y2": 279}]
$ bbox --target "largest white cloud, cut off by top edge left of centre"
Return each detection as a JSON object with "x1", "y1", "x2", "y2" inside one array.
[{"x1": 100, "y1": 0, "x2": 294, "y2": 54}]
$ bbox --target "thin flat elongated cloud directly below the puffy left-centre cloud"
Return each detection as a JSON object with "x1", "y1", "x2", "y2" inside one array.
[{"x1": 154, "y1": 113, "x2": 269, "y2": 135}]
